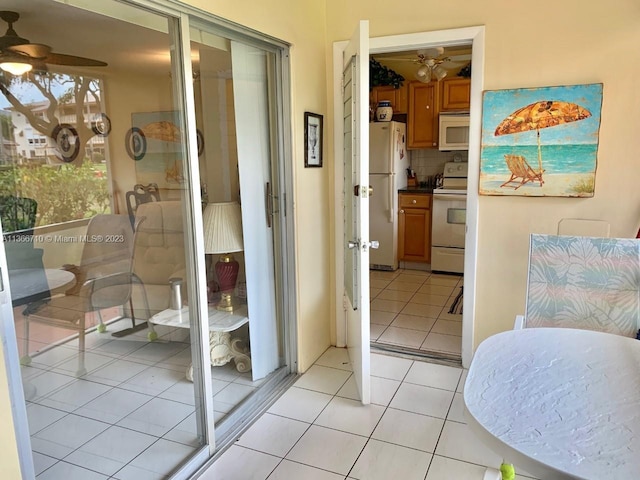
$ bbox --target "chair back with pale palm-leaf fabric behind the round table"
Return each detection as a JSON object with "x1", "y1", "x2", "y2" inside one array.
[{"x1": 515, "y1": 234, "x2": 640, "y2": 337}]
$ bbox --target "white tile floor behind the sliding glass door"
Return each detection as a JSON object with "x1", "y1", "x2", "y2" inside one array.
[{"x1": 22, "y1": 320, "x2": 261, "y2": 480}]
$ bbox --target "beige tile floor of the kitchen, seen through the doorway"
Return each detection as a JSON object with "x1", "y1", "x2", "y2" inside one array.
[{"x1": 369, "y1": 269, "x2": 463, "y2": 359}]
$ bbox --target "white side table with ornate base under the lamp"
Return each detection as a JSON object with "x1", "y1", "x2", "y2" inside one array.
[{"x1": 148, "y1": 305, "x2": 251, "y2": 381}]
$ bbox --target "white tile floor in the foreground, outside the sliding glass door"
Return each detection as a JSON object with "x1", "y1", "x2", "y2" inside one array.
[{"x1": 199, "y1": 347, "x2": 533, "y2": 480}]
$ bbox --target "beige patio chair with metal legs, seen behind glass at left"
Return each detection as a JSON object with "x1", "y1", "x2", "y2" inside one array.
[{"x1": 20, "y1": 214, "x2": 144, "y2": 376}]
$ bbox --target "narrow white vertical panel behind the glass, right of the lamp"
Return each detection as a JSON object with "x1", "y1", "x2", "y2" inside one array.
[{"x1": 231, "y1": 41, "x2": 280, "y2": 380}]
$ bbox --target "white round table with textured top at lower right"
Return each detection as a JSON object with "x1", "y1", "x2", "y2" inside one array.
[{"x1": 464, "y1": 328, "x2": 640, "y2": 480}]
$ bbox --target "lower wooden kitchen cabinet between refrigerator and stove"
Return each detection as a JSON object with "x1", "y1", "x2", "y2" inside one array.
[{"x1": 398, "y1": 193, "x2": 431, "y2": 263}]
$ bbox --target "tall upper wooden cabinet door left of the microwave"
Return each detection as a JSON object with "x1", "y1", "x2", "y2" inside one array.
[{"x1": 407, "y1": 82, "x2": 438, "y2": 148}]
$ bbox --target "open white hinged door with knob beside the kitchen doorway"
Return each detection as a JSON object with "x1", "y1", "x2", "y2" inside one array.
[{"x1": 342, "y1": 20, "x2": 371, "y2": 405}]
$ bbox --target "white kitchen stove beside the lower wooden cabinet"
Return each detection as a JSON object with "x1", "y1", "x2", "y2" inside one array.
[{"x1": 431, "y1": 162, "x2": 469, "y2": 273}]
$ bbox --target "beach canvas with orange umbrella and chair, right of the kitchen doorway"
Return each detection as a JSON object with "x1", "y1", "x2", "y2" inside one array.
[{"x1": 480, "y1": 83, "x2": 602, "y2": 197}]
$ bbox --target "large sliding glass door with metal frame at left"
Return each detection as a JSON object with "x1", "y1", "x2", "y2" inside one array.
[{"x1": 0, "y1": 0, "x2": 290, "y2": 479}]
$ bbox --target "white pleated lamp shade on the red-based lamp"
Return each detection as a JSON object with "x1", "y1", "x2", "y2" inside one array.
[{"x1": 202, "y1": 202, "x2": 243, "y2": 253}]
